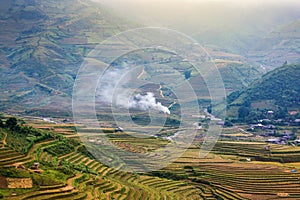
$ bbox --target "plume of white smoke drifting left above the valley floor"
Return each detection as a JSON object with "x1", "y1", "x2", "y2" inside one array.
[{"x1": 96, "y1": 63, "x2": 170, "y2": 114}]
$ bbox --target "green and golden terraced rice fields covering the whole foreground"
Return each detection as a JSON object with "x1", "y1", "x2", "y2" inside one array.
[{"x1": 0, "y1": 116, "x2": 300, "y2": 200}]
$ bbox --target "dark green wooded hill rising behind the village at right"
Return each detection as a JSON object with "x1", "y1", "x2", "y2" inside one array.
[{"x1": 229, "y1": 65, "x2": 300, "y2": 117}]
